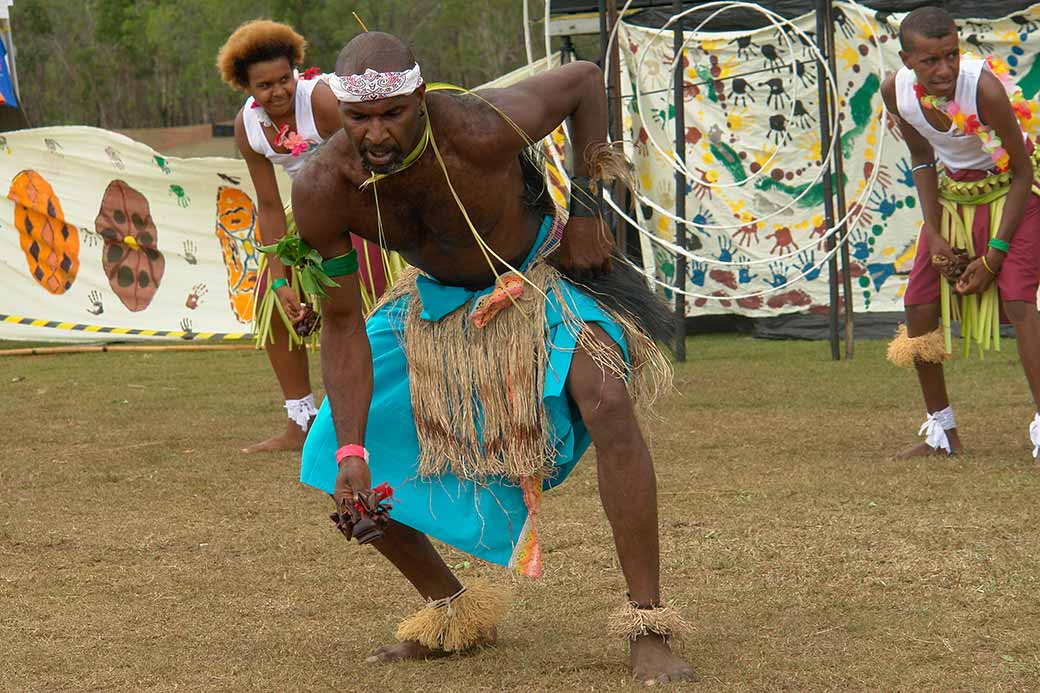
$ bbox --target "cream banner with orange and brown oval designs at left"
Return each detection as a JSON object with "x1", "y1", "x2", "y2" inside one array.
[{"x1": 0, "y1": 127, "x2": 289, "y2": 341}]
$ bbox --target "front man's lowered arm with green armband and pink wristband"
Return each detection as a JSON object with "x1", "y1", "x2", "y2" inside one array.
[{"x1": 292, "y1": 168, "x2": 372, "y2": 507}]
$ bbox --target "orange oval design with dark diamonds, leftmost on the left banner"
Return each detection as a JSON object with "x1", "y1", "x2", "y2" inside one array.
[{"x1": 7, "y1": 171, "x2": 79, "y2": 296}]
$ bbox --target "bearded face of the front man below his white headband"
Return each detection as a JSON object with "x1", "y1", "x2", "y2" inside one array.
[{"x1": 339, "y1": 85, "x2": 428, "y2": 174}]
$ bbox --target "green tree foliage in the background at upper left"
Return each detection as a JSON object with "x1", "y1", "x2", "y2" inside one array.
[{"x1": 11, "y1": 0, "x2": 544, "y2": 128}]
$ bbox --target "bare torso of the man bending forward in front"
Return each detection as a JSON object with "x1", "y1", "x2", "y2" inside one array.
[{"x1": 294, "y1": 94, "x2": 541, "y2": 287}]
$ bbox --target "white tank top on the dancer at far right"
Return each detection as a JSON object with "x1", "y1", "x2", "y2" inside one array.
[{"x1": 895, "y1": 59, "x2": 994, "y2": 171}]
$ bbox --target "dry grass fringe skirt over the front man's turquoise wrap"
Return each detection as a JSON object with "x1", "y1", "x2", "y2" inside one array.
[{"x1": 379, "y1": 261, "x2": 672, "y2": 483}]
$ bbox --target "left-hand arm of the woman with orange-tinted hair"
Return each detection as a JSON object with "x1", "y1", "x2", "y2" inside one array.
[{"x1": 241, "y1": 111, "x2": 304, "y2": 322}]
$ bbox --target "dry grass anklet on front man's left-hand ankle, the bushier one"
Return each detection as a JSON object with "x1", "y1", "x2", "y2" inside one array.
[{"x1": 396, "y1": 580, "x2": 513, "y2": 652}]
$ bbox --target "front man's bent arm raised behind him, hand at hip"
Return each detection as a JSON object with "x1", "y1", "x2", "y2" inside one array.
[{"x1": 480, "y1": 60, "x2": 614, "y2": 277}]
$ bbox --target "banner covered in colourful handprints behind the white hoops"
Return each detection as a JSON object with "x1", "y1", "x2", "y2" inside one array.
[{"x1": 620, "y1": 3, "x2": 1040, "y2": 316}]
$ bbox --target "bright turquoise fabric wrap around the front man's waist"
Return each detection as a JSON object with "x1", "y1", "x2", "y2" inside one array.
[{"x1": 300, "y1": 217, "x2": 628, "y2": 565}]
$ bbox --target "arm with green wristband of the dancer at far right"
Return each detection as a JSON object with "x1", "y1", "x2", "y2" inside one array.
[{"x1": 957, "y1": 72, "x2": 1033, "y2": 293}]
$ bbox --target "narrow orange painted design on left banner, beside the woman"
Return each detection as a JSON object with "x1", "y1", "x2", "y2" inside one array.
[{"x1": 216, "y1": 185, "x2": 260, "y2": 323}]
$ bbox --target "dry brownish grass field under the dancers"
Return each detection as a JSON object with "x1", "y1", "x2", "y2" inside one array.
[{"x1": 0, "y1": 336, "x2": 1040, "y2": 692}]
